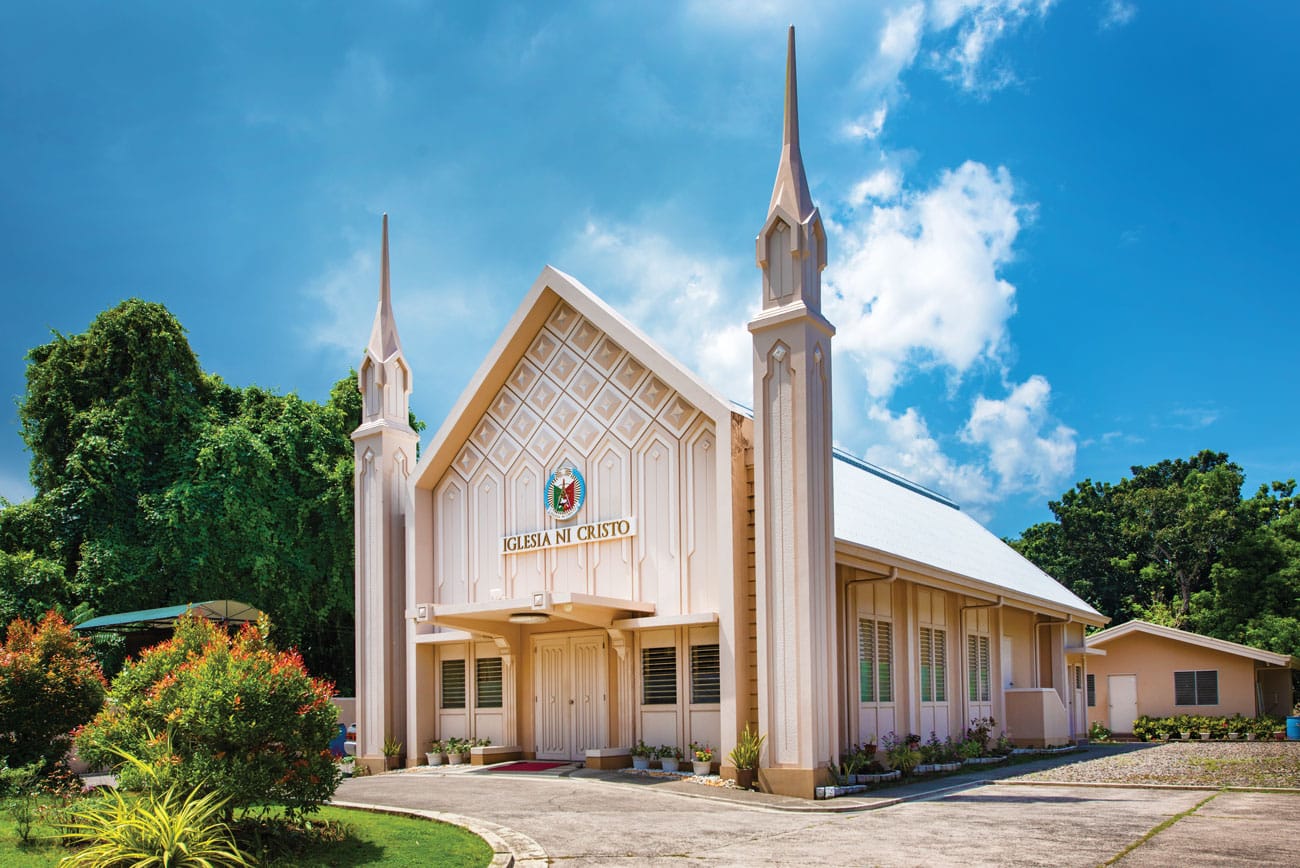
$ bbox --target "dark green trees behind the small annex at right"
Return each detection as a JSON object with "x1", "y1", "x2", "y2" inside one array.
[{"x1": 1010, "y1": 451, "x2": 1300, "y2": 654}]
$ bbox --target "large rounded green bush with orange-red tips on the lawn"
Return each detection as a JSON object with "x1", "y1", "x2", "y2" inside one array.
[{"x1": 77, "y1": 616, "x2": 339, "y2": 819}]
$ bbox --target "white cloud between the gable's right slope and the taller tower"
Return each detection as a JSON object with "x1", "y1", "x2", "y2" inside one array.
[{"x1": 560, "y1": 221, "x2": 759, "y2": 404}]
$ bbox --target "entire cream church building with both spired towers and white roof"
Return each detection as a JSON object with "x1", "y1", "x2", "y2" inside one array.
[{"x1": 352, "y1": 30, "x2": 1105, "y2": 797}]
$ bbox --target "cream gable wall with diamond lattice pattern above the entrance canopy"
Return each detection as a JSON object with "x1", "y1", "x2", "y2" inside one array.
[{"x1": 421, "y1": 281, "x2": 719, "y2": 615}]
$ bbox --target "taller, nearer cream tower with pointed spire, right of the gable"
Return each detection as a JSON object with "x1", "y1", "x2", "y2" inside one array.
[{"x1": 749, "y1": 26, "x2": 840, "y2": 798}]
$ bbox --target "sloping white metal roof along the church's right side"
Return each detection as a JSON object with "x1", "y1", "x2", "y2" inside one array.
[{"x1": 835, "y1": 451, "x2": 1105, "y2": 621}]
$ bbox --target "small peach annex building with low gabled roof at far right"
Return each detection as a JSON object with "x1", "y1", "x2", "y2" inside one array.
[{"x1": 1086, "y1": 621, "x2": 1300, "y2": 733}]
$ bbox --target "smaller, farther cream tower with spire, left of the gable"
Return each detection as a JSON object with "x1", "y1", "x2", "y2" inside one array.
[{"x1": 352, "y1": 214, "x2": 420, "y2": 771}]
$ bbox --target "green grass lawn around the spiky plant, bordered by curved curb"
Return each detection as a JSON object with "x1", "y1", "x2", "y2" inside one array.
[{"x1": 0, "y1": 808, "x2": 491, "y2": 868}]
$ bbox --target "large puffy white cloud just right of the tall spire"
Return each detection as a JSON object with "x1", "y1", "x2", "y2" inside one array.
[{"x1": 826, "y1": 162, "x2": 1031, "y2": 399}]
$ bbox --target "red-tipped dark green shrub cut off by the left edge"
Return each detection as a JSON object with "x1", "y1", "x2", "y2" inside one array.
[{"x1": 0, "y1": 612, "x2": 104, "y2": 767}]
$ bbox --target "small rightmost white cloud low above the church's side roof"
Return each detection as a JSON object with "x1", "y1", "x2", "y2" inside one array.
[{"x1": 962, "y1": 376, "x2": 1076, "y2": 495}]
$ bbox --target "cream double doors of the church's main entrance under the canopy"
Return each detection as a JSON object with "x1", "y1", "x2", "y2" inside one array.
[{"x1": 533, "y1": 633, "x2": 610, "y2": 760}]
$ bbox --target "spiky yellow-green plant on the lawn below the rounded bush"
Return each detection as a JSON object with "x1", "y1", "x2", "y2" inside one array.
[{"x1": 59, "y1": 751, "x2": 250, "y2": 868}]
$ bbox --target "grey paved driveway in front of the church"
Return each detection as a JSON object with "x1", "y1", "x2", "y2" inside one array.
[{"x1": 337, "y1": 772, "x2": 1300, "y2": 865}]
